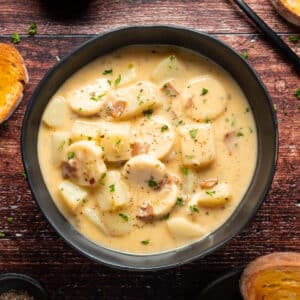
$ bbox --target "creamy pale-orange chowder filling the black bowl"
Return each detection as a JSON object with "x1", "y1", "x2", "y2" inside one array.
[{"x1": 38, "y1": 46, "x2": 257, "y2": 253}]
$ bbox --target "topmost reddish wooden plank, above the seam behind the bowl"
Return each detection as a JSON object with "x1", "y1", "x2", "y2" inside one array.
[{"x1": 0, "y1": 0, "x2": 299, "y2": 35}]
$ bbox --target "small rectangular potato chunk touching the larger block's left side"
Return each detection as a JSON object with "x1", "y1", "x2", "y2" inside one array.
[{"x1": 71, "y1": 120, "x2": 100, "y2": 140}]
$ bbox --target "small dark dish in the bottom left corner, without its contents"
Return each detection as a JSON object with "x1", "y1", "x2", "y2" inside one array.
[{"x1": 0, "y1": 273, "x2": 49, "y2": 300}]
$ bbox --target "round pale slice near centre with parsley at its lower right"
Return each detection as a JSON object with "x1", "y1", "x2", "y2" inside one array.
[{"x1": 122, "y1": 154, "x2": 167, "y2": 189}]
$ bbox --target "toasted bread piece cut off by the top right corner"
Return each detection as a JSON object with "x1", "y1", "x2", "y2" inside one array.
[{"x1": 271, "y1": 0, "x2": 300, "y2": 26}]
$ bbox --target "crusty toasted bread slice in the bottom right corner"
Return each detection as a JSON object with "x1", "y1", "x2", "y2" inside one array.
[{"x1": 240, "y1": 252, "x2": 300, "y2": 300}]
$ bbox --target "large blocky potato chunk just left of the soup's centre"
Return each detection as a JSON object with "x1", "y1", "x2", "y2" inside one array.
[{"x1": 100, "y1": 122, "x2": 131, "y2": 162}]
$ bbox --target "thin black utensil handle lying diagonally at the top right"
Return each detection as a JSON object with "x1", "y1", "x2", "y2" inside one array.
[{"x1": 234, "y1": 0, "x2": 300, "y2": 73}]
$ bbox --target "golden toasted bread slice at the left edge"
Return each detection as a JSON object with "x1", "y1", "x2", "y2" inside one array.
[{"x1": 0, "y1": 43, "x2": 28, "y2": 124}]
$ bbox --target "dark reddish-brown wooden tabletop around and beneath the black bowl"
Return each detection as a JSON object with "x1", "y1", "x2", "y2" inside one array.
[{"x1": 0, "y1": 0, "x2": 300, "y2": 300}]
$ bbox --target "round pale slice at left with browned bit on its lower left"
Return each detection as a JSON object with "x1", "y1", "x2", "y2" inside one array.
[{"x1": 62, "y1": 141, "x2": 106, "y2": 187}]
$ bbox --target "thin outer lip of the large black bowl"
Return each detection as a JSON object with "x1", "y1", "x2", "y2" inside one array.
[{"x1": 21, "y1": 24, "x2": 278, "y2": 271}]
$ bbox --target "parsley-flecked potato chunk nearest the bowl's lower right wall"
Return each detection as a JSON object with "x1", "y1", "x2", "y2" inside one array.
[{"x1": 189, "y1": 182, "x2": 231, "y2": 207}]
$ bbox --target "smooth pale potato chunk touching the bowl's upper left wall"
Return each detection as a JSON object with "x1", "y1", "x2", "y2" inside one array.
[{"x1": 42, "y1": 96, "x2": 70, "y2": 128}]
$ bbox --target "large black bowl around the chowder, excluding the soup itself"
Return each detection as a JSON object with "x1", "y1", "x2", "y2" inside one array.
[{"x1": 21, "y1": 26, "x2": 278, "y2": 270}]
